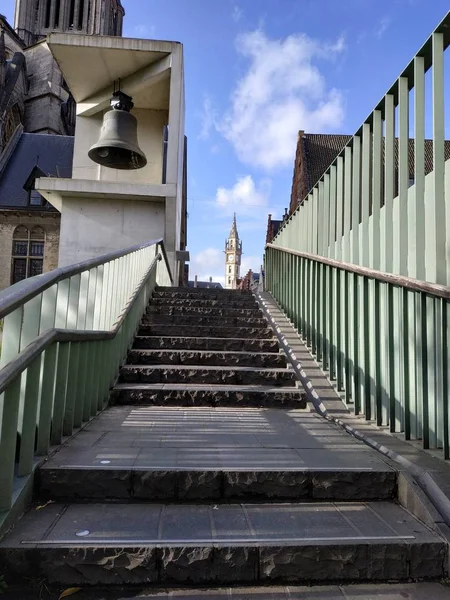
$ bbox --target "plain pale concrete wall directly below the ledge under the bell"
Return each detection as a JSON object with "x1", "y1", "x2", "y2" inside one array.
[{"x1": 58, "y1": 198, "x2": 164, "y2": 267}]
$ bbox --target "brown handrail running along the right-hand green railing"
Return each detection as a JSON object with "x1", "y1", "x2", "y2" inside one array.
[{"x1": 266, "y1": 244, "x2": 450, "y2": 300}]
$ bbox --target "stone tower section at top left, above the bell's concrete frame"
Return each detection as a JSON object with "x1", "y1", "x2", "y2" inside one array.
[{"x1": 14, "y1": 0, "x2": 125, "y2": 46}]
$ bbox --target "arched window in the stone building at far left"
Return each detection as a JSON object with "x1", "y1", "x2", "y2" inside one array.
[{"x1": 11, "y1": 225, "x2": 45, "y2": 284}]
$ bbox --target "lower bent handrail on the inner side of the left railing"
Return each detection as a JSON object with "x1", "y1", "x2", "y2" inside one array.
[{"x1": 0, "y1": 251, "x2": 162, "y2": 394}]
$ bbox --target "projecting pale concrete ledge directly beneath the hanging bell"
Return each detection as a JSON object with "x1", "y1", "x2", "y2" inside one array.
[{"x1": 35, "y1": 177, "x2": 176, "y2": 211}]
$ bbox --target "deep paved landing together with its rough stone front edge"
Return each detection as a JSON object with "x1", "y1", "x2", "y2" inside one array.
[{"x1": 39, "y1": 406, "x2": 397, "y2": 502}]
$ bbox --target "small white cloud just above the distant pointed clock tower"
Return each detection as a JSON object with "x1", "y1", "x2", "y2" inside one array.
[{"x1": 216, "y1": 175, "x2": 271, "y2": 217}]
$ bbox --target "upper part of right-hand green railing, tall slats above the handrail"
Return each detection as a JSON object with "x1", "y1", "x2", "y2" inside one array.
[{"x1": 272, "y1": 12, "x2": 450, "y2": 285}]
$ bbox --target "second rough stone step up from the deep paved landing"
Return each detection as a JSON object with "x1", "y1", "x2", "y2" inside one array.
[{"x1": 119, "y1": 364, "x2": 297, "y2": 387}]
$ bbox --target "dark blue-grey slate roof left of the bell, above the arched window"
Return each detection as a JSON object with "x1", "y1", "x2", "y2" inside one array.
[{"x1": 0, "y1": 133, "x2": 74, "y2": 208}]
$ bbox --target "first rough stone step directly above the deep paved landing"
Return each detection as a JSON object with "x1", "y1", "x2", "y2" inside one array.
[{"x1": 111, "y1": 383, "x2": 306, "y2": 408}]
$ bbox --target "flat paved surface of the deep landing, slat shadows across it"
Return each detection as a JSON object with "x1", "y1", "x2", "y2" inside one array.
[{"x1": 44, "y1": 406, "x2": 391, "y2": 471}]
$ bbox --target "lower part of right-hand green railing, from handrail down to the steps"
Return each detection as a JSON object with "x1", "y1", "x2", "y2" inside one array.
[{"x1": 266, "y1": 244, "x2": 450, "y2": 458}]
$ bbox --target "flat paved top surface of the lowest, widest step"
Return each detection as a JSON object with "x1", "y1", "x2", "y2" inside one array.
[{"x1": 0, "y1": 502, "x2": 438, "y2": 548}]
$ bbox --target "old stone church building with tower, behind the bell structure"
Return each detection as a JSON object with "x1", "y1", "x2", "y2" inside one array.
[{"x1": 0, "y1": 0, "x2": 125, "y2": 289}]
